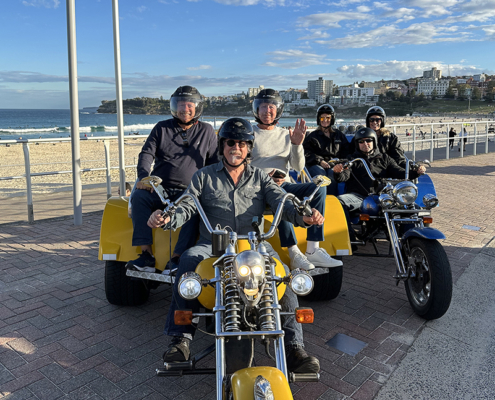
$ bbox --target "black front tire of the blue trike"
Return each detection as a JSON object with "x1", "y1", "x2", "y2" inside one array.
[{"x1": 405, "y1": 238, "x2": 452, "y2": 320}]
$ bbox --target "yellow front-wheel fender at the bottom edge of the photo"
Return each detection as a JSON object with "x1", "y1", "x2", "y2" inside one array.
[{"x1": 231, "y1": 367, "x2": 293, "y2": 400}]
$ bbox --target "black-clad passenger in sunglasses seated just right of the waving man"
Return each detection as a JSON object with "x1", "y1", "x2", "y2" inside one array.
[{"x1": 303, "y1": 104, "x2": 349, "y2": 196}]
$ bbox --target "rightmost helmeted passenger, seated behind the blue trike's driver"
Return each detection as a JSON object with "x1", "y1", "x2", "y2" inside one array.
[{"x1": 366, "y1": 106, "x2": 406, "y2": 168}]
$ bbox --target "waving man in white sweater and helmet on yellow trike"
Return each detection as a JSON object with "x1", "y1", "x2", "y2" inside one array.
[{"x1": 253, "y1": 89, "x2": 342, "y2": 270}]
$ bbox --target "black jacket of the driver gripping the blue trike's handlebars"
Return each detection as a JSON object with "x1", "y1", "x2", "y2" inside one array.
[{"x1": 334, "y1": 150, "x2": 419, "y2": 197}]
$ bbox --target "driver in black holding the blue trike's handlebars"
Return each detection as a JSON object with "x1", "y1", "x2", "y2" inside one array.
[{"x1": 333, "y1": 128, "x2": 426, "y2": 242}]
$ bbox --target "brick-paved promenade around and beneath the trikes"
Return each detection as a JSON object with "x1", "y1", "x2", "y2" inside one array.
[{"x1": 0, "y1": 154, "x2": 495, "y2": 400}]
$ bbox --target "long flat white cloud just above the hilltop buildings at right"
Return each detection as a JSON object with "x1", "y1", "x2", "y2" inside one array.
[{"x1": 337, "y1": 60, "x2": 489, "y2": 79}]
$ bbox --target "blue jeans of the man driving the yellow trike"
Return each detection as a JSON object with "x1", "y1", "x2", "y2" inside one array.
[{"x1": 165, "y1": 240, "x2": 304, "y2": 347}]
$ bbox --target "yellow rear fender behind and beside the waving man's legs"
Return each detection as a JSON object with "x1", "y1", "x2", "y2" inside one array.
[{"x1": 265, "y1": 196, "x2": 352, "y2": 265}]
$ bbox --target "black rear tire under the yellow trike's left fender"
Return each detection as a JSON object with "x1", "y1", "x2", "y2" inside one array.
[{"x1": 105, "y1": 261, "x2": 150, "y2": 306}]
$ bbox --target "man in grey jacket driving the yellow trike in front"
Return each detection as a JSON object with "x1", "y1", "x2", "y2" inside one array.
[{"x1": 148, "y1": 118, "x2": 324, "y2": 373}]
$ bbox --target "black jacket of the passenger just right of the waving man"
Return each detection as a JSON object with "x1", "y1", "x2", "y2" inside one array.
[{"x1": 303, "y1": 129, "x2": 350, "y2": 167}]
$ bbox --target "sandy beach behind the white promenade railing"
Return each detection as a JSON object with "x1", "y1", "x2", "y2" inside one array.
[{"x1": 0, "y1": 117, "x2": 492, "y2": 198}]
